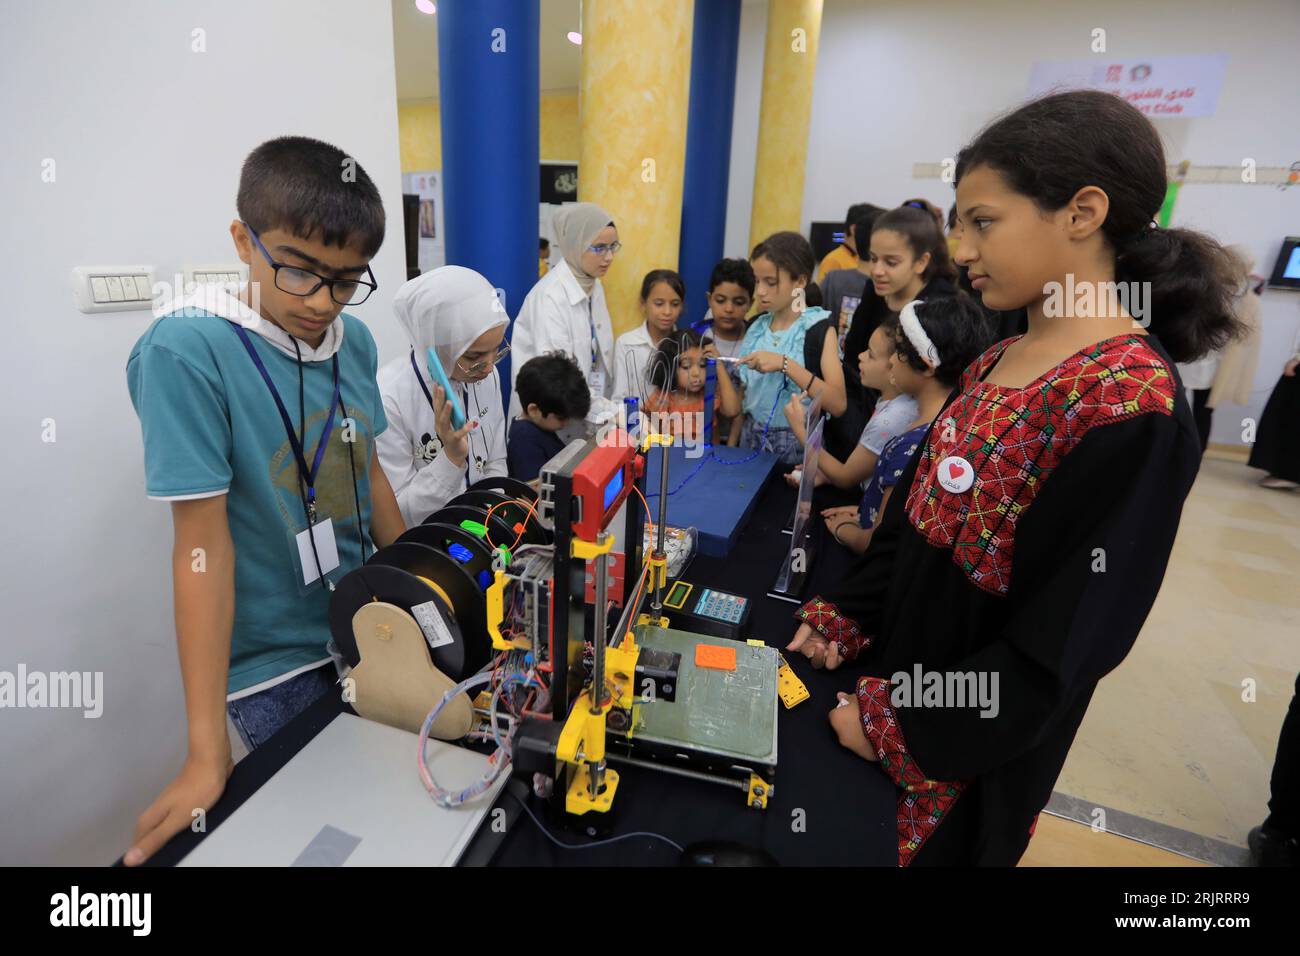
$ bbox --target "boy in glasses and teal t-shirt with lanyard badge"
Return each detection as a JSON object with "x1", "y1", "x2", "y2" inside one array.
[{"x1": 124, "y1": 137, "x2": 404, "y2": 865}]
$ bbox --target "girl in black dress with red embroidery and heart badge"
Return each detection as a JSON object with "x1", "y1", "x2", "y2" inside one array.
[{"x1": 789, "y1": 91, "x2": 1236, "y2": 865}]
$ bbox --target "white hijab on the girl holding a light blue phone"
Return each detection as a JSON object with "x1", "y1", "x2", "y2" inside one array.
[{"x1": 393, "y1": 265, "x2": 510, "y2": 376}]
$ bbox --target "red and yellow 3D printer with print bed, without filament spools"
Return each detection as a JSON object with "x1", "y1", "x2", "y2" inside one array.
[{"x1": 501, "y1": 429, "x2": 779, "y2": 817}]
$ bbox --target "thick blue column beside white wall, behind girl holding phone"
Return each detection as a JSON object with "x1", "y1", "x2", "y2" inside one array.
[{"x1": 437, "y1": 0, "x2": 540, "y2": 399}]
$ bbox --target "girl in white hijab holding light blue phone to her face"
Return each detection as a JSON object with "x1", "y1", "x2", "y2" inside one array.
[{"x1": 376, "y1": 265, "x2": 510, "y2": 527}]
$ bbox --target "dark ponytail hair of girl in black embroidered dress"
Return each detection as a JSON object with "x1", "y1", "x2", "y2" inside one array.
[{"x1": 957, "y1": 90, "x2": 1242, "y2": 362}]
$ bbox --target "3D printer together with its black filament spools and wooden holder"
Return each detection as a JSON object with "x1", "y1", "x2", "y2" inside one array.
[{"x1": 330, "y1": 429, "x2": 780, "y2": 823}]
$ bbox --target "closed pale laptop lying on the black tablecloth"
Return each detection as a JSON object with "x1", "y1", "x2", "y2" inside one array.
[{"x1": 181, "y1": 714, "x2": 508, "y2": 866}]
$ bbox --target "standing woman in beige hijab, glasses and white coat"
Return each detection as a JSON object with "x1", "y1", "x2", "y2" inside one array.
[{"x1": 510, "y1": 203, "x2": 620, "y2": 424}]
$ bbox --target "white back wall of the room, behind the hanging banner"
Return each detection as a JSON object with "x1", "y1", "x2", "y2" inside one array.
[{"x1": 727, "y1": 0, "x2": 1300, "y2": 444}]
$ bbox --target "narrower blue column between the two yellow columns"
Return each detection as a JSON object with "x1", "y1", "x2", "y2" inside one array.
[{"x1": 679, "y1": 0, "x2": 740, "y2": 325}]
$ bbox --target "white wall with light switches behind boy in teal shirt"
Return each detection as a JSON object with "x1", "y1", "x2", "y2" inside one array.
[{"x1": 0, "y1": 0, "x2": 406, "y2": 864}]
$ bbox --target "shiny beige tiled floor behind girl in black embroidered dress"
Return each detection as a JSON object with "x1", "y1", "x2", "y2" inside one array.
[{"x1": 1057, "y1": 458, "x2": 1300, "y2": 865}]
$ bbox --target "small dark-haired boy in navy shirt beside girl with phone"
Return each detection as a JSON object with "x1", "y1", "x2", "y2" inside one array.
[{"x1": 506, "y1": 352, "x2": 592, "y2": 481}]
